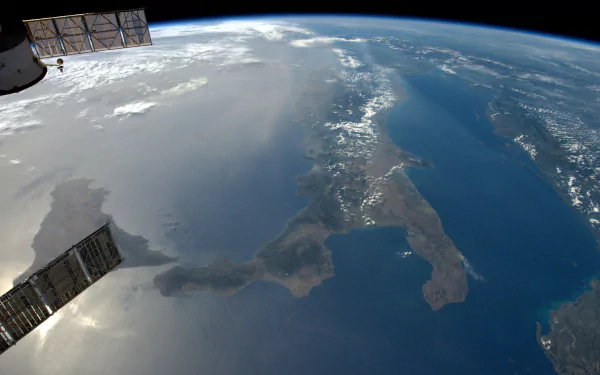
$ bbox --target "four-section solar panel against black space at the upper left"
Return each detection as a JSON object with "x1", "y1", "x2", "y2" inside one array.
[{"x1": 23, "y1": 9, "x2": 152, "y2": 58}]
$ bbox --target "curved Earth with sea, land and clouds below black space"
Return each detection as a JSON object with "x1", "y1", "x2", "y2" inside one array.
[{"x1": 0, "y1": 16, "x2": 600, "y2": 375}]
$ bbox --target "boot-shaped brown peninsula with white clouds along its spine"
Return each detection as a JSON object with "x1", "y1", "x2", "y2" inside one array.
[{"x1": 154, "y1": 69, "x2": 468, "y2": 309}]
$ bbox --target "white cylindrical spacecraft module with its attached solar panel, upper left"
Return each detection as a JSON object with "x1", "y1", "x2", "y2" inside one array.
[{"x1": 0, "y1": 9, "x2": 152, "y2": 95}]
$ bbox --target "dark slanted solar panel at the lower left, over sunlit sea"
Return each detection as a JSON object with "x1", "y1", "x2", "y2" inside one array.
[{"x1": 0, "y1": 223, "x2": 123, "y2": 354}]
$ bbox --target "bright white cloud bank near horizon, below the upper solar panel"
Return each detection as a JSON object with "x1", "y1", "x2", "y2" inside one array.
[{"x1": 0, "y1": 20, "x2": 332, "y2": 136}]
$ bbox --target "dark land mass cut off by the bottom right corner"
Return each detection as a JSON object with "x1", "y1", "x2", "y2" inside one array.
[{"x1": 537, "y1": 280, "x2": 600, "y2": 375}]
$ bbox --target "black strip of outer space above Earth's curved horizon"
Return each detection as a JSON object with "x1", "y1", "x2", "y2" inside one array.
[{"x1": 0, "y1": 0, "x2": 600, "y2": 42}]
